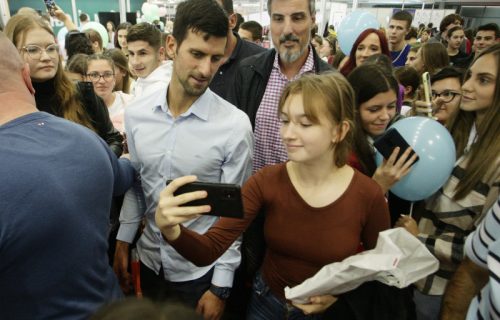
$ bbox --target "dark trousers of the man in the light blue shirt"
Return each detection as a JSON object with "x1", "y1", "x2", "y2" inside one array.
[{"x1": 141, "y1": 262, "x2": 213, "y2": 308}]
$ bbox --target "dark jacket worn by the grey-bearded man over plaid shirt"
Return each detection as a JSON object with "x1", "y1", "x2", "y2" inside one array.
[{"x1": 227, "y1": 48, "x2": 332, "y2": 127}]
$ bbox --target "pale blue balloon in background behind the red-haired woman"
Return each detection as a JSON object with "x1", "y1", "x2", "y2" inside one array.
[{"x1": 338, "y1": 10, "x2": 380, "y2": 56}]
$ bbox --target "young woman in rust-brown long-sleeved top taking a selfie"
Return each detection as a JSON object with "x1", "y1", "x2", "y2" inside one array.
[{"x1": 156, "y1": 74, "x2": 390, "y2": 319}]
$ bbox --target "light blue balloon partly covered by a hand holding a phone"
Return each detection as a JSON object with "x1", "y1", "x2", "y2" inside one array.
[{"x1": 376, "y1": 117, "x2": 456, "y2": 201}]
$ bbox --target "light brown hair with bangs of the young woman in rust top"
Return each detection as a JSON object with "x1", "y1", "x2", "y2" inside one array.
[{"x1": 278, "y1": 72, "x2": 355, "y2": 167}]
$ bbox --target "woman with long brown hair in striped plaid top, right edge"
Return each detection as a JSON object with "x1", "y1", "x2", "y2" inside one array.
[{"x1": 396, "y1": 44, "x2": 500, "y2": 319}]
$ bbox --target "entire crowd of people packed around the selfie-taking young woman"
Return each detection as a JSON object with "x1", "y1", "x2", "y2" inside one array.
[{"x1": 0, "y1": 0, "x2": 500, "y2": 320}]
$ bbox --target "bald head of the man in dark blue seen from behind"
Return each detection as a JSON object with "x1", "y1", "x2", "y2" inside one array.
[{"x1": 0, "y1": 31, "x2": 29, "y2": 92}]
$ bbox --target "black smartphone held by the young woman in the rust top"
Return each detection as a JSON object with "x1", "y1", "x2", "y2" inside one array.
[{"x1": 167, "y1": 180, "x2": 243, "y2": 219}]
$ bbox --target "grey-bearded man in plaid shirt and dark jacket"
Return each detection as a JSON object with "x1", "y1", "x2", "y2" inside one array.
[{"x1": 228, "y1": 0, "x2": 331, "y2": 172}]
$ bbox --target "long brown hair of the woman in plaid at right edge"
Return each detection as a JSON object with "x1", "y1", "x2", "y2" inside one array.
[{"x1": 448, "y1": 44, "x2": 500, "y2": 200}]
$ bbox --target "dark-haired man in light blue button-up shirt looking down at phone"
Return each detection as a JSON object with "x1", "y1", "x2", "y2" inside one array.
[{"x1": 114, "y1": 0, "x2": 253, "y2": 319}]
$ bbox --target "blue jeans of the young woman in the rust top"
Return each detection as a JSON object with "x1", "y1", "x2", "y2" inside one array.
[{"x1": 247, "y1": 272, "x2": 322, "y2": 320}]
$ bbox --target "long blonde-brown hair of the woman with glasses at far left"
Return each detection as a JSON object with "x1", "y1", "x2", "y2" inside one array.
[{"x1": 5, "y1": 15, "x2": 95, "y2": 130}]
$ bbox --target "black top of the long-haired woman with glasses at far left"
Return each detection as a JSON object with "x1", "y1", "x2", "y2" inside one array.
[{"x1": 33, "y1": 79, "x2": 123, "y2": 157}]
